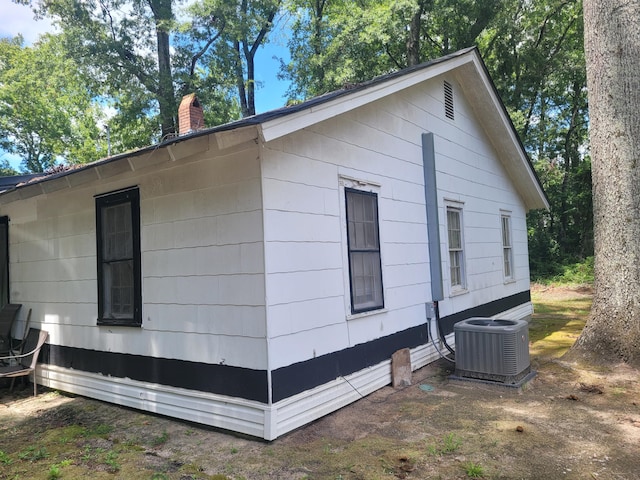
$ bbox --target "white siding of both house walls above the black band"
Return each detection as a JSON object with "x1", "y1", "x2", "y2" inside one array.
[{"x1": 0, "y1": 74, "x2": 528, "y2": 382}]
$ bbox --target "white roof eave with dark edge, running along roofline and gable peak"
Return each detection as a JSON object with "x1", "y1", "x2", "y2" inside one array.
[{"x1": 0, "y1": 47, "x2": 549, "y2": 209}]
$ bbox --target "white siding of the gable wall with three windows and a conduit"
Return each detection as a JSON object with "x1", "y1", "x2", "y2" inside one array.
[{"x1": 263, "y1": 73, "x2": 528, "y2": 369}]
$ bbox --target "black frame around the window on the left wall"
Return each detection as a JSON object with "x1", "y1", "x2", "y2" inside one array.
[{"x1": 95, "y1": 187, "x2": 142, "y2": 327}]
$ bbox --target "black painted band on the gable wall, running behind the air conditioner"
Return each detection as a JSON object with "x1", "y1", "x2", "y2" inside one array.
[{"x1": 271, "y1": 290, "x2": 531, "y2": 403}]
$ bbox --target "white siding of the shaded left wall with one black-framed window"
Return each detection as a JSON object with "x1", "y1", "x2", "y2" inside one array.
[{"x1": 0, "y1": 139, "x2": 267, "y2": 369}]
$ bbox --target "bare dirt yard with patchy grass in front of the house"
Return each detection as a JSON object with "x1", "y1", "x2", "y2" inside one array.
[{"x1": 0, "y1": 287, "x2": 640, "y2": 480}]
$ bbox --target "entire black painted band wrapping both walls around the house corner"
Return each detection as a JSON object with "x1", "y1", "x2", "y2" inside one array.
[{"x1": 42, "y1": 290, "x2": 531, "y2": 404}]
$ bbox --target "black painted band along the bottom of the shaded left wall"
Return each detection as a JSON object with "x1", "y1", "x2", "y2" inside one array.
[{"x1": 42, "y1": 344, "x2": 268, "y2": 403}]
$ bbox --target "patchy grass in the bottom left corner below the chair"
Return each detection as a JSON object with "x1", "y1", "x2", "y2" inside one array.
[{"x1": 0, "y1": 402, "x2": 208, "y2": 480}]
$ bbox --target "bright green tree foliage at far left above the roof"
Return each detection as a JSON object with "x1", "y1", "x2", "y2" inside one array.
[{"x1": 0, "y1": 35, "x2": 101, "y2": 172}]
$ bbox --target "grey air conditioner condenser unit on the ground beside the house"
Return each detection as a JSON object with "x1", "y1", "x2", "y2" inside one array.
[{"x1": 453, "y1": 317, "x2": 531, "y2": 384}]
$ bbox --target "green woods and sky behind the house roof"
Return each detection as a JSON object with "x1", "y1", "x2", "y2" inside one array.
[{"x1": 0, "y1": 0, "x2": 594, "y2": 279}]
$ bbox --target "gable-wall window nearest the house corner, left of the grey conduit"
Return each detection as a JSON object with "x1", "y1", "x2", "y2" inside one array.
[{"x1": 345, "y1": 188, "x2": 384, "y2": 313}]
